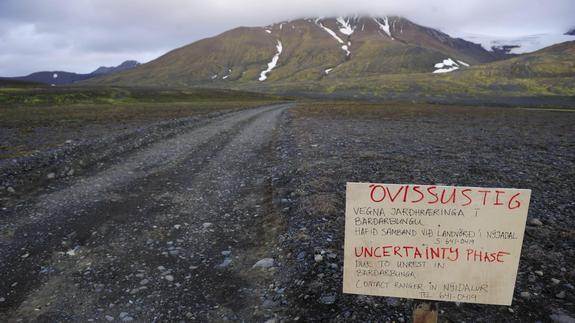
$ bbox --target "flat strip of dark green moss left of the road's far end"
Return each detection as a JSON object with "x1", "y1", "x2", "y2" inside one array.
[{"x1": 0, "y1": 87, "x2": 286, "y2": 129}]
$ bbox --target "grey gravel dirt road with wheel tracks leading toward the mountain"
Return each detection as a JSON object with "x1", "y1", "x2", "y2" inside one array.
[{"x1": 0, "y1": 105, "x2": 290, "y2": 322}]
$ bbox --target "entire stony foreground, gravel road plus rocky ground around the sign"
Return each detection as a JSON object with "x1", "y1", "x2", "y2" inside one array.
[{"x1": 0, "y1": 103, "x2": 575, "y2": 322}]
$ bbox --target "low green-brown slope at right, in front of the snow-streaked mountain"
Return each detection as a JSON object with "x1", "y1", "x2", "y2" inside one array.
[{"x1": 233, "y1": 41, "x2": 575, "y2": 100}]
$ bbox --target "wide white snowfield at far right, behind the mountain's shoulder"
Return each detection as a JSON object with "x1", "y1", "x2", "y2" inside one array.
[{"x1": 453, "y1": 33, "x2": 575, "y2": 54}]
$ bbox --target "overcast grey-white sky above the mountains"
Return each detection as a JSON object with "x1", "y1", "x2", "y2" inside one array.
[{"x1": 0, "y1": 0, "x2": 575, "y2": 76}]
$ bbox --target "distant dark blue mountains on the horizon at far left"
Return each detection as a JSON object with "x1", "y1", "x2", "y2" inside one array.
[{"x1": 3, "y1": 61, "x2": 140, "y2": 85}]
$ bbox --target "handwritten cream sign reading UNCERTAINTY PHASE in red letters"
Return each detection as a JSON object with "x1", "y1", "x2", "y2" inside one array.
[{"x1": 343, "y1": 183, "x2": 531, "y2": 305}]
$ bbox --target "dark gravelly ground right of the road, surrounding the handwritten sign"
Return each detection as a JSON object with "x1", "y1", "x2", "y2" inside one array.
[{"x1": 278, "y1": 104, "x2": 575, "y2": 322}]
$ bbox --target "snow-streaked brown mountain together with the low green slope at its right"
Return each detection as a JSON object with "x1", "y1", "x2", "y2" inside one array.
[{"x1": 83, "y1": 17, "x2": 575, "y2": 102}]
